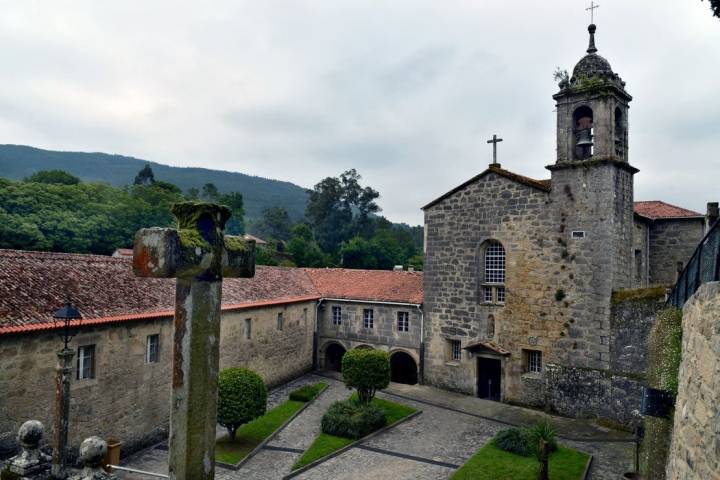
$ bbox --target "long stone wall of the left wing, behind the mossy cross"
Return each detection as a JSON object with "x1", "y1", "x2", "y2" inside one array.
[{"x1": 0, "y1": 301, "x2": 315, "y2": 456}]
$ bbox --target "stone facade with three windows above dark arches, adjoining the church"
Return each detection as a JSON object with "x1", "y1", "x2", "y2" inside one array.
[{"x1": 318, "y1": 300, "x2": 423, "y2": 374}]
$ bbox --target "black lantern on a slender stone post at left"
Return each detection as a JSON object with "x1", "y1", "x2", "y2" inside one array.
[{"x1": 51, "y1": 301, "x2": 82, "y2": 479}]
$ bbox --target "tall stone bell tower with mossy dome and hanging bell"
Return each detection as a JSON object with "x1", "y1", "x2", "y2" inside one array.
[{"x1": 547, "y1": 25, "x2": 638, "y2": 368}]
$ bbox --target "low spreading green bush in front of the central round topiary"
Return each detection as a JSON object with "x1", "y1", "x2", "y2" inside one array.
[{"x1": 322, "y1": 400, "x2": 385, "y2": 438}]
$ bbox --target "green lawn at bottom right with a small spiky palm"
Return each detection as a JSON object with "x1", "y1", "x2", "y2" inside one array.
[{"x1": 450, "y1": 440, "x2": 590, "y2": 480}]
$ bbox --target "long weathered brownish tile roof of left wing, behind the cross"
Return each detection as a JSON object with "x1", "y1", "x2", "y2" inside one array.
[{"x1": 0, "y1": 250, "x2": 319, "y2": 333}]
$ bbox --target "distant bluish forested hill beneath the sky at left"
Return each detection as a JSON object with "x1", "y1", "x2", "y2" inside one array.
[{"x1": 0, "y1": 145, "x2": 307, "y2": 220}]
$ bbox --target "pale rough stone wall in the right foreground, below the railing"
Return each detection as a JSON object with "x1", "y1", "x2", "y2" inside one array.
[{"x1": 667, "y1": 282, "x2": 720, "y2": 480}]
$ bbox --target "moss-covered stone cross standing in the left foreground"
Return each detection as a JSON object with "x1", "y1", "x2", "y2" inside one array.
[{"x1": 133, "y1": 202, "x2": 255, "y2": 480}]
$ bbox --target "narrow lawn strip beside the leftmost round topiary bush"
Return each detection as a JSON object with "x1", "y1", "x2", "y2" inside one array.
[{"x1": 215, "y1": 382, "x2": 327, "y2": 465}]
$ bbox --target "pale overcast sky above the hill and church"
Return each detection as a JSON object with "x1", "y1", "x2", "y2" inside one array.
[{"x1": 0, "y1": 0, "x2": 720, "y2": 224}]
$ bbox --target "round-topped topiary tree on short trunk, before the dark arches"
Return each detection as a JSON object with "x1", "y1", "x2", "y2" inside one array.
[{"x1": 342, "y1": 348, "x2": 390, "y2": 404}]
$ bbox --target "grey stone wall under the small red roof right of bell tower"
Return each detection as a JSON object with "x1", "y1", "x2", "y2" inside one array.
[{"x1": 650, "y1": 218, "x2": 705, "y2": 285}]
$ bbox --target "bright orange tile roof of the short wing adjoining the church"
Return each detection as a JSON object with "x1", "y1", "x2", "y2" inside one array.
[{"x1": 305, "y1": 268, "x2": 423, "y2": 305}]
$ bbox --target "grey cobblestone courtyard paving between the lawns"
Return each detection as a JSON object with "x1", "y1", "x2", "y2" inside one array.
[{"x1": 122, "y1": 375, "x2": 633, "y2": 480}]
